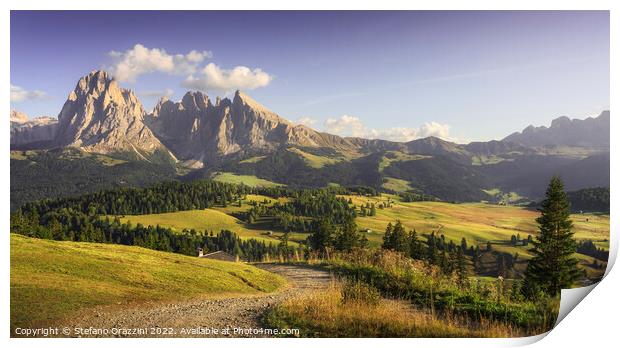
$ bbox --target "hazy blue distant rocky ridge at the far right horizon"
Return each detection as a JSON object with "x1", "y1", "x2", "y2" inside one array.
[{"x1": 504, "y1": 111, "x2": 610, "y2": 148}]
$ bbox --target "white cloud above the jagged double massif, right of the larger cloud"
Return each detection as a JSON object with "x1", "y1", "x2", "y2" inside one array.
[{"x1": 183, "y1": 63, "x2": 273, "y2": 91}]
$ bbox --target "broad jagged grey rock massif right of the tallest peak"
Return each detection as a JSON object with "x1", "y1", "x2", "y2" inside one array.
[{"x1": 148, "y1": 91, "x2": 364, "y2": 162}]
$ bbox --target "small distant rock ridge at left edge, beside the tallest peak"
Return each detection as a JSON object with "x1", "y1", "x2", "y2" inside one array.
[{"x1": 11, "y1": 110, "x2": 58, "y2": 145}]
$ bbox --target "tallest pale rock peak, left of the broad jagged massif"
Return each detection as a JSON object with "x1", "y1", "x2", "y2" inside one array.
[{"x1": 55, "y1": 71, "x2": 165, "y2": 157}]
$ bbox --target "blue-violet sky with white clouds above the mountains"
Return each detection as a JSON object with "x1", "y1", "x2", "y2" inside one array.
[{"x1": 10, "y1": 11, "x2": 610, "y2": 141}]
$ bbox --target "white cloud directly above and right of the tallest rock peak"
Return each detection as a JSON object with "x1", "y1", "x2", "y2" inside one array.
[{"x1": 108, "y1": 44, "x2": 213, "y2": 82}]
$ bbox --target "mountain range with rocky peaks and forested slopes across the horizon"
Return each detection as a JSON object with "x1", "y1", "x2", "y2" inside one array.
[{"x1": 11, "y1": 71, "x2": 610, "y2": 207}]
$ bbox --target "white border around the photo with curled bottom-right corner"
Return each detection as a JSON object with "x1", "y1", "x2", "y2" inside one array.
[{"x1": 0, "y1": 0, "x2": 620, "y2": 348}]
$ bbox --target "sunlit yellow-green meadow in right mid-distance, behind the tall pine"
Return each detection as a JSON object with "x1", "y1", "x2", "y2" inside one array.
[{"x1": 344, "y1": 195, "x2": 609, "y2": 250}]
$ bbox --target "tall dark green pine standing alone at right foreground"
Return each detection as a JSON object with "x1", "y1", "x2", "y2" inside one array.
[{"x1": 524, "y1": 176, "x2": 581, "y2": 296}]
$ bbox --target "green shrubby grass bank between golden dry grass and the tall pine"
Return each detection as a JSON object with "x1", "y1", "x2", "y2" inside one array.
[{"x1": 278, "y1": 249, "x2": 559, "y2": 336}]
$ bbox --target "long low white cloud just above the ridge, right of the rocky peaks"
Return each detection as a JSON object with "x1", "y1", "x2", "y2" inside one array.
[{"x1": 323, "y1": 115, "x2": 452, "y2": 142}]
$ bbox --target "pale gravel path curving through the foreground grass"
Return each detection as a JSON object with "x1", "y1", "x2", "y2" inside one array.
[{"x1": 62, "y1": 264, "x2": 330, "y2": 337}]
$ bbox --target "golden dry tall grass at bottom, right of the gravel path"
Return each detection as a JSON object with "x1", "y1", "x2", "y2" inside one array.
[{"x1": 265, "y1": 281, "x2": 522, "y2": 337}]
